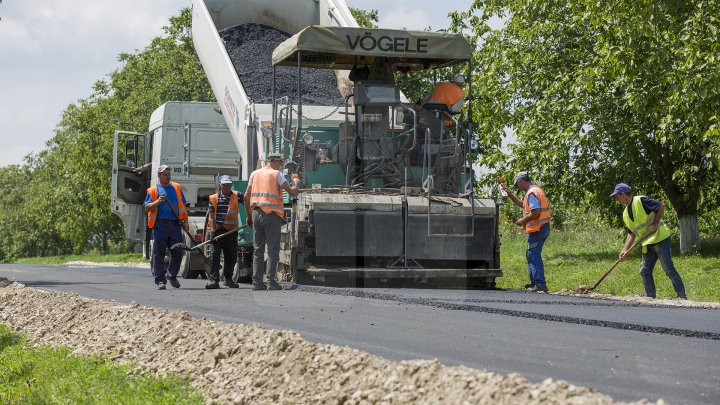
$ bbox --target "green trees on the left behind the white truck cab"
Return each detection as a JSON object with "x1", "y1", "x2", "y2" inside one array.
[{"x1": 0, "y1": 8, "x2": 214, "y2": 261}]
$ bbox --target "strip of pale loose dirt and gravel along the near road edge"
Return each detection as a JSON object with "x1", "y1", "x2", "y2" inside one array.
[{"x1": 0, "y1": 280, "x2": 662, "y2": 404}]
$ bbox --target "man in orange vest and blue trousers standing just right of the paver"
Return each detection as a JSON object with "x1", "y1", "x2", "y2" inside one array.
[{"x1": 500, "y1": 172, "x2": 550, "y2": 292}]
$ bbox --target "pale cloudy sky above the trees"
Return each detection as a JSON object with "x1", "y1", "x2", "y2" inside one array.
[{"x1": 0, "y1": 0, "x2": 472, "y2": 166}]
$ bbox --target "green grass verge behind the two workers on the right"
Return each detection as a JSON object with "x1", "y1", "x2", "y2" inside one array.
[{"x1": 497, "y1": 224, "x2": 720, "y2": 301}]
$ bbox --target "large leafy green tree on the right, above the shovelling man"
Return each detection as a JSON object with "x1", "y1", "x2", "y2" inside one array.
[{"x1": 453, "y1": 0, "x2": 720, "y2": 253}]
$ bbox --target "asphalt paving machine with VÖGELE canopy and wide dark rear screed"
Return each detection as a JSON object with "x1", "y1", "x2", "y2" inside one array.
[{"x1": 264, "y1": 26, "x2": 502, "y2": 288}]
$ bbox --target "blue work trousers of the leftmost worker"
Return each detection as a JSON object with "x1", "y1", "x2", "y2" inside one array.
[{"x1": 152, "y1": 220, "x2": 183, "y2": 284}]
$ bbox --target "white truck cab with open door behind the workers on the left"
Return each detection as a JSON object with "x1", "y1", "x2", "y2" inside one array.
[{"x1": 111, "y1": 101, "x2": 242, "y2": 278}]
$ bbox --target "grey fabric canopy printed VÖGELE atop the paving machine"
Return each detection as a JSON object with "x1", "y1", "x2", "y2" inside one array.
[{"x1": 272, "y1": 25, "x2": 472, "y2": 69}]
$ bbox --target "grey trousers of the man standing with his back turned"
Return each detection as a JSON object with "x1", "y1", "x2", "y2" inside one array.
[{"x1": 252, "y1": 208, "x2": 285, "y2": 284}]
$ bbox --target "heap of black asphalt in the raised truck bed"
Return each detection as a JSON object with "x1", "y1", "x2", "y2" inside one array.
[{"x1": 220, "y1": 23, "x2": 342, "y2": 106}]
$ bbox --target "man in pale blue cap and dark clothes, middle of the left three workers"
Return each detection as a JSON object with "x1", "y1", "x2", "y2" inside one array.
[{"x1": 205, "y1": 175, "x2": 243, "y2": 290}]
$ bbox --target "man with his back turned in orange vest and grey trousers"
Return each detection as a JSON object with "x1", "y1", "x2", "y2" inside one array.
[{"x1": 245, "y1": 153, "x2": 299, "y2": 291}]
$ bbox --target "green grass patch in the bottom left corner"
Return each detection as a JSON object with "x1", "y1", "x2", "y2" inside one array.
[{"x1": 0, "y1": 324, "x2": 204, "y2": 404}]
